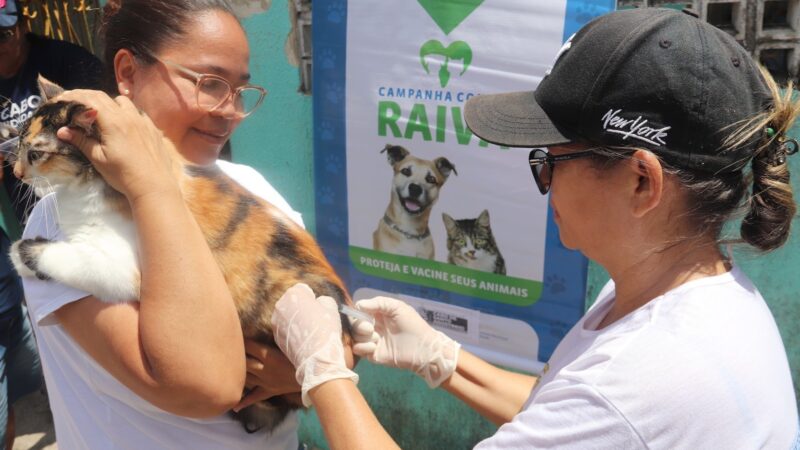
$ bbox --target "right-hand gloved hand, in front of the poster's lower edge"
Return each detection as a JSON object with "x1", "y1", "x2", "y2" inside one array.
[{"x1": 353, "y1": 297, "x2": 461, "y2": 388}]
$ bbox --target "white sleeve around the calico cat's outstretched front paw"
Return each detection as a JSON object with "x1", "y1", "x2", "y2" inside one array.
[{"x1": 22, "y1": 194, "x2": 90, "y2": 325}]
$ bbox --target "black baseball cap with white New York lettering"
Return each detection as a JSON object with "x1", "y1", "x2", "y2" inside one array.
[{"x1": 465, "y1": 8, "x2": 772, "y2": 173}]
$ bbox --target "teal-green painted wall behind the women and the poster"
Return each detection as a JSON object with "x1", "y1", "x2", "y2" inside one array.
[{"x1": 239, "y1": 7, "x2": 800, "y2": 449}]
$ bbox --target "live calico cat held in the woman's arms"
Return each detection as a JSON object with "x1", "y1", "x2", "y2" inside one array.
[{"x1": 2, "y1": 79, "x2": 352, "y2": 432}]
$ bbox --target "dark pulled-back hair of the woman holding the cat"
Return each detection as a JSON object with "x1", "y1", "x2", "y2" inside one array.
[{"x1": 99, "y1": 0, "x2": 236, "y2": 92}]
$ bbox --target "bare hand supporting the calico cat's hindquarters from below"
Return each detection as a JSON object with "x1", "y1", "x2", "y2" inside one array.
[{"x1": 233, "y1": 339, "x2": 300, "y2": 412}]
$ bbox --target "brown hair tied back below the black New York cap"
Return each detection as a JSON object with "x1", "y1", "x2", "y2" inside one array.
[{"x1": 593, "y1": 67, "x2": 800, "y2": 252}]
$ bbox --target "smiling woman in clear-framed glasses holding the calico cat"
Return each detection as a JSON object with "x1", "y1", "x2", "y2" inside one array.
[{"x1": 20, "y1": 0, "x2": 300, "y2": 449}]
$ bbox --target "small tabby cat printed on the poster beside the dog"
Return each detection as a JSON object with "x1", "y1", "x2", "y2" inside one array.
[{"x1": 442, "y1": 209, "x2": 506, "y2": 275}]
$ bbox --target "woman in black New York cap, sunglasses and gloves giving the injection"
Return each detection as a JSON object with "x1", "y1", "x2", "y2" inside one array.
[{"x1": 260, "y1": 9, "x2": 800, "y2": 448}]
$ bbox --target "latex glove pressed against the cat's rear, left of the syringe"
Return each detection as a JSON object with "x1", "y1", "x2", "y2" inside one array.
[{"x1": 272, "y1": 283, "x2": 358, "y2": 406}]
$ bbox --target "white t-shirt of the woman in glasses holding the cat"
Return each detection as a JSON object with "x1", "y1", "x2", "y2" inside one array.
[{"x1": 23, "y1": 161, "x2": 303, "y2": 450}]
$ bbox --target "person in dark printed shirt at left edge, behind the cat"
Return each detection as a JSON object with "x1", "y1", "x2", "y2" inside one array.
[{"x1": 0, "y1": 0, "x2": 102, "y2": 448}]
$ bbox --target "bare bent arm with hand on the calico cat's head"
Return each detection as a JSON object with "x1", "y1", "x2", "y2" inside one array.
[{"x1": 55, "y1": 91, "x2": 245, "y2": 417}]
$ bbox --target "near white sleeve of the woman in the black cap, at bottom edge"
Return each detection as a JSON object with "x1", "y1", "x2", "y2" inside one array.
[{"x1": 475, "y1": 379, "x2": 647, "y2": 450}]
